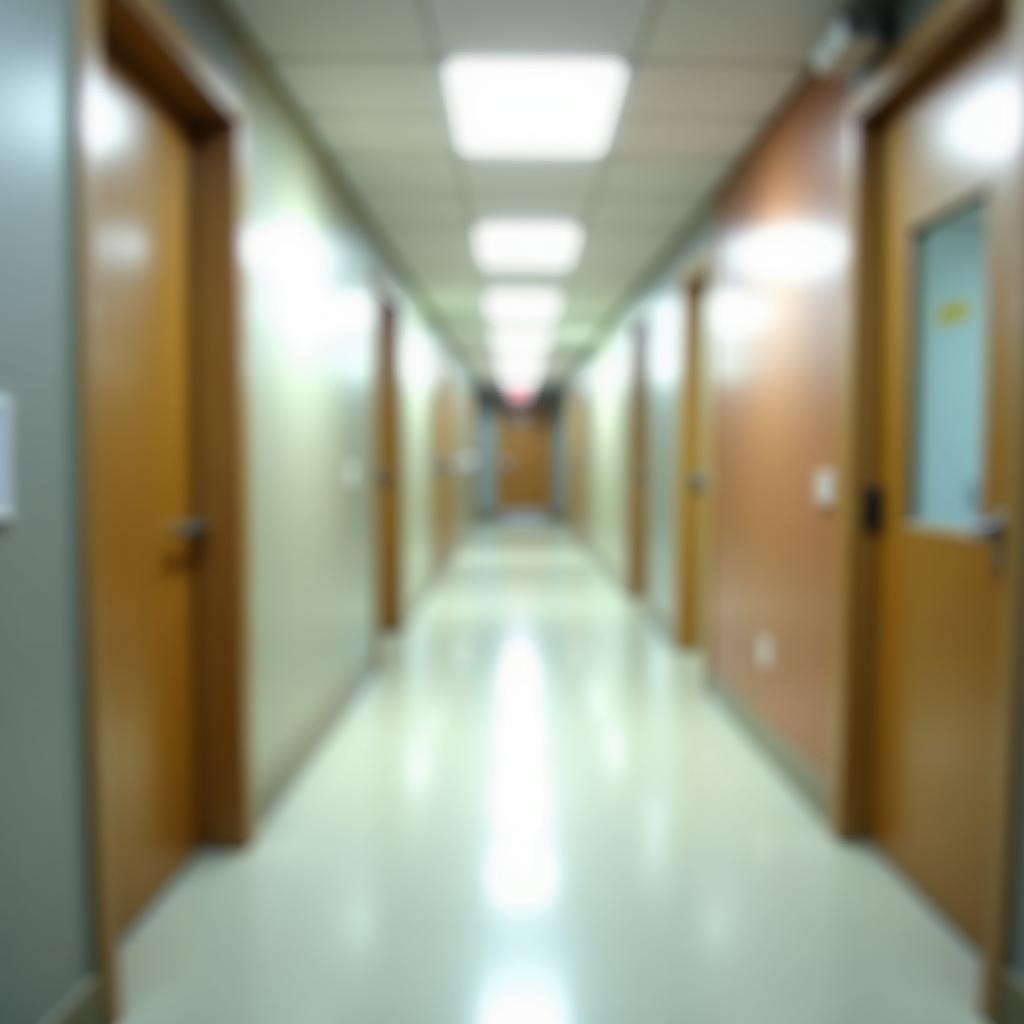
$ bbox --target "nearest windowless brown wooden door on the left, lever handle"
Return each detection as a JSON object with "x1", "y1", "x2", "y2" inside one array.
[{"x1": 85, "y1": 61, "x2": 197, "y2": 928}]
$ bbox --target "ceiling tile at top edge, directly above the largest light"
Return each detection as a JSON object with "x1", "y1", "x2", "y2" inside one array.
[{"x1": 431, "y1": 0, "x2": 647, "y2": 53}]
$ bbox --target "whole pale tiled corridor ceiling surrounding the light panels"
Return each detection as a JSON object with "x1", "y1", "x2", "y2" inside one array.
[{"x1": 220, "y1": 0, "x2": 840, "y2": 375}]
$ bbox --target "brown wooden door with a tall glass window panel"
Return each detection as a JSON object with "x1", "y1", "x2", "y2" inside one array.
[{"x1": 873, "y1": 28, "x2": 1020, "y2": 938}]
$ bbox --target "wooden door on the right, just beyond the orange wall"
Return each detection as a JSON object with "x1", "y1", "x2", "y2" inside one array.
[{"x1": 679, "y1": 283, "x2": 712, "y2": 647}]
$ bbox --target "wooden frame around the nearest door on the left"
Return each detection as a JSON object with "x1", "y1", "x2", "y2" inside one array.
[{"x1": 73, "y1": 0, "x2": 253, "y2": 1020}]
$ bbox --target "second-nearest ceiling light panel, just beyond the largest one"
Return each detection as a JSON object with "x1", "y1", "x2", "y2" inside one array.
[{"x1": 470, "y1": 217, "x2": 586, "y2": 274}]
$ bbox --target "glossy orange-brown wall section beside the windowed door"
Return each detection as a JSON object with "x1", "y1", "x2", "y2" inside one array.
[{"x1": 706, "y1": 86, "x2": 849, "y2": 772}]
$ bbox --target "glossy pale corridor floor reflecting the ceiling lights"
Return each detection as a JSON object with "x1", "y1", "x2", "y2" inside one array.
[{"x1": 125, "y1": 527, "x2": 977, "y2": 1024}]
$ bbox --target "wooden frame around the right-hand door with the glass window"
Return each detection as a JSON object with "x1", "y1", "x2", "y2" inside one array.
[{"x1": 831, "y1": 0, "x2": 1024, "y2": 1015}]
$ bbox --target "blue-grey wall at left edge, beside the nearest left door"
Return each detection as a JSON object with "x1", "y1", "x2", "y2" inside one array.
[{"x1": 0, "y1": 0, "x2": 93, "y2": 1024}]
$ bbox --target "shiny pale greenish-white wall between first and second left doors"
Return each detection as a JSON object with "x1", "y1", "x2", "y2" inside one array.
[{"x1": 242, "y1": 68, "x2": 378, "y2": 804}]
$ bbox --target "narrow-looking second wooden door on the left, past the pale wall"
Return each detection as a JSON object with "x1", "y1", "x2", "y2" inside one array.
[{"x1": 377, "y1": 305, "x2": 401, "y2": 630}]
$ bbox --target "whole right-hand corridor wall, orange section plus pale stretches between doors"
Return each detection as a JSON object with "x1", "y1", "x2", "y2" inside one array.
[{"x1": 570, "y1": 86, "x2": 849, "y2": 777}]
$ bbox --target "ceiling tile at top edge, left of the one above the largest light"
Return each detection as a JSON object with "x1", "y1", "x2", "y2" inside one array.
[{"x1": 229, "y1": 0, "x2": 429, "y2": 59}]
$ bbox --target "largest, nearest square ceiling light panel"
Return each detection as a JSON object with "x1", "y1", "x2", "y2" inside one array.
[{"x1": 441, "y1": 54, "x2": 630, "y2": 161}]
